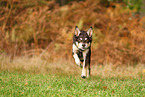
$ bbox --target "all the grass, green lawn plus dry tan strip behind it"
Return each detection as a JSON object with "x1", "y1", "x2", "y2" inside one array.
[{"x1": 0, "y1": 55, "x2": 145, "y2": 97}]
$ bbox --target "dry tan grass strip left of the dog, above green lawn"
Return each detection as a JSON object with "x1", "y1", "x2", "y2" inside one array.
[{"x1": 0, "y1": 54, "x2": 79, "y2": 74}]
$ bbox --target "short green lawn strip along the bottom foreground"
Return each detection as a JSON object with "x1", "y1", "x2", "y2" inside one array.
[{"x1": 0, "y1": 71, "x2": 145, "y2": 97}]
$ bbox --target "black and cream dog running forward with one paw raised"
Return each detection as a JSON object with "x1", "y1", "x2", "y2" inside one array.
[{"x1": 72, "y1": 26, "x2": 93, "y2": 78}]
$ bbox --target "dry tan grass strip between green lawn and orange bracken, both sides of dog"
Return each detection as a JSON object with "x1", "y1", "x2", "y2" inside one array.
[{"x1": 0, "y1": 54, "x2": 145, "y2": 79}]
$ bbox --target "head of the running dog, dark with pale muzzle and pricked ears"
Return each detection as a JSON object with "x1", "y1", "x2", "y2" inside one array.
[{"x1": 75, "y1": 26, "x2": 93, "y2": 50}]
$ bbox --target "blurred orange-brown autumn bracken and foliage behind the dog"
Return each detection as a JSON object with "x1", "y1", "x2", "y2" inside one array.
[{"x1": 0, "y1": 0, "x2": 145, "y2": 66}]
